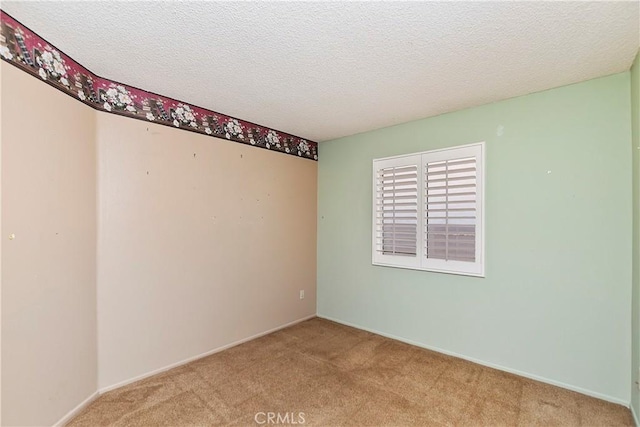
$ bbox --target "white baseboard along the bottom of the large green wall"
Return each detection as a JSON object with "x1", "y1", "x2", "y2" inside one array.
[{"x1": 318, "y1": 314, "x2": 638, "y2": 408}]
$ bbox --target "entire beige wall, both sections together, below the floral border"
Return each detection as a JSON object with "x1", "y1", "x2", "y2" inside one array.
[{"x1": 0, "y1": 63, "x2": 317, "y2": 425}]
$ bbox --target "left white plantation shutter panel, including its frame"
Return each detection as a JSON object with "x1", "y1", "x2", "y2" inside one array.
[{"x1": 373, "y1": 156, "x2": 422, "y2": 266}]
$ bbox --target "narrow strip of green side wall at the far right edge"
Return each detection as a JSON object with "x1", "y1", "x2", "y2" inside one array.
[{"x1": 631, "y1": 53, "x2": 640, "y2": 420}]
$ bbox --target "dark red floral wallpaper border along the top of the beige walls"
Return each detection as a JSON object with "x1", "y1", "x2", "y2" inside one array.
[{"x1": 0, "y1": 10, "x2": 318, "y2": 160}]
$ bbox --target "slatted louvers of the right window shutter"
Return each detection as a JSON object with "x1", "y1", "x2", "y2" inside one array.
[{"x1": 424, "y1": 157, "x2": 477, "y2": 262}]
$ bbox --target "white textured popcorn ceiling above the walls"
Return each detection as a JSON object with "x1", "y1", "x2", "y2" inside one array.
[{"x1": 1, "y1": 1, "x2": 640, "y2": 141}]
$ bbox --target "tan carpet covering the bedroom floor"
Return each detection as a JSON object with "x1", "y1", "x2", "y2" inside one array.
[{"x1": 69, "y1": 318, "x2": 633, "y2": 427}]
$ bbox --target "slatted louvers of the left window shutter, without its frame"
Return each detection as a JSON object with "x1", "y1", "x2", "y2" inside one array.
[{"x1": 375, "y1": 165, "x2": 419, "y2": 257}]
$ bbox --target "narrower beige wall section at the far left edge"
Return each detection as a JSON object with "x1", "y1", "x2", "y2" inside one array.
[{"x1": 1, "y1": 62, "x2": 97, "y2": 425}]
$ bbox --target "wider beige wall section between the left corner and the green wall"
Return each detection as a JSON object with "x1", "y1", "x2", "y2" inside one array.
[{"x1": 97, "y1": 113, "x2": 317, "y2": 388}]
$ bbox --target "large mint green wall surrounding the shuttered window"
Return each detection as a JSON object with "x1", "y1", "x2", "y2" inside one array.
[{"x1": 318, "y1": 72, "x2": 632, "y2": 404}]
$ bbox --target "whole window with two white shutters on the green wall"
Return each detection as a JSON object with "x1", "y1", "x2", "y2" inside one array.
[{"x1": 372, "y1": 143, "x2": 484, "y2": 276}]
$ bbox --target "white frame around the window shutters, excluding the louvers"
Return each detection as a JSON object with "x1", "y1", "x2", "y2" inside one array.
[{"x1": 371, "y1": 142, "x2": 485, "y2": 277}]
